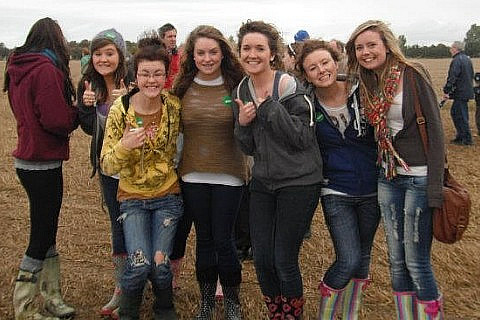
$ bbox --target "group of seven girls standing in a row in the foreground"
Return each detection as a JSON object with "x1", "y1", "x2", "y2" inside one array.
[{"x1": 4, "y1": 18, "x2": 444, "y2": 319}]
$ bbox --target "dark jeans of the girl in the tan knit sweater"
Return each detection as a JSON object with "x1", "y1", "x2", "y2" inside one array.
[{"x1": 182, "y1": 182, "x2": 243, "y2": 287}]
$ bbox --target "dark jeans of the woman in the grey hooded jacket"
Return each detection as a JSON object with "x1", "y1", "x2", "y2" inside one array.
[{"x1": 250, "y1": 178, "x2": 321, "y2": 298}]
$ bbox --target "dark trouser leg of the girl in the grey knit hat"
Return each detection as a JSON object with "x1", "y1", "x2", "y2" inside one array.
[{"x1": 99, "y1": 173, "x2": 127, "y2": 255}]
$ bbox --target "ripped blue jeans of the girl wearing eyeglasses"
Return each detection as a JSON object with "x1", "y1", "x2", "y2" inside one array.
[{"x1": 120, "y1": 194, "x2": 183, "y2": 296}]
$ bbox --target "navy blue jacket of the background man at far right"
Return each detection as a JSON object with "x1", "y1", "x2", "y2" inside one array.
[{"x1": 443, "y1": 51, "x2": 474, "y2": 100}]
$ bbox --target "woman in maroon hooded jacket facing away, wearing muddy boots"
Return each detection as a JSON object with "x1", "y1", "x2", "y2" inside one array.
[{"x1": 3, "y1": 18, "x2": 77, "y2": 319}]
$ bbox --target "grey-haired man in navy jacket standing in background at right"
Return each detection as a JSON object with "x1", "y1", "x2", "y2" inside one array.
[{"x1": 443, "y1": 41, "x2": 473, "y2": 146}]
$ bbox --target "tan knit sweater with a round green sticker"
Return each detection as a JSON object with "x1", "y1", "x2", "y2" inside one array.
[{"x1": 178, "y1": 82, "x2": 247, "y2": 181}]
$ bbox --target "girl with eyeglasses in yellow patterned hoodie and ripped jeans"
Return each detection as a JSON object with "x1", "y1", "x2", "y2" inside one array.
[{"x1": 100, "y1": 43, "x2": 183, "y2": 319}]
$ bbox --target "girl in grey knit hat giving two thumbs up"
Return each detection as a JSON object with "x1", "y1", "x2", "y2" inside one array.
[{"x1": 77, "y1": 29, "x2": 133, "y2": 317}]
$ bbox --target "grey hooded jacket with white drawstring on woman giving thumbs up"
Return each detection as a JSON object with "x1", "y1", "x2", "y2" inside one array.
[{"x1": 232, "y1": 71, "x2": 323, "y2": 190}]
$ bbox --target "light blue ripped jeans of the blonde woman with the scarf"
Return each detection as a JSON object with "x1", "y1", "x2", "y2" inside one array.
[{"x1": 378, "y1": 170, "x2": 439, "y2": 300}]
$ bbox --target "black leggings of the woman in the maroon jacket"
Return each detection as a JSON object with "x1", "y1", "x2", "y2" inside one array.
[{"x1": 17, "y1": 167, "x2": 63, "y2": 260}]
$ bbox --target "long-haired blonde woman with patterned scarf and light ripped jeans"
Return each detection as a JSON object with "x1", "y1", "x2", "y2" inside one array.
[{"x1": 346, "y1": 20, "x2": 445, "y2": 320}]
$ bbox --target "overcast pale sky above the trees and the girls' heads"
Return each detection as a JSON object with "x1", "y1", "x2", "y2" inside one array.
[{"x1": 0, "y1": 0, "x2": 480, "y2": 48}]
